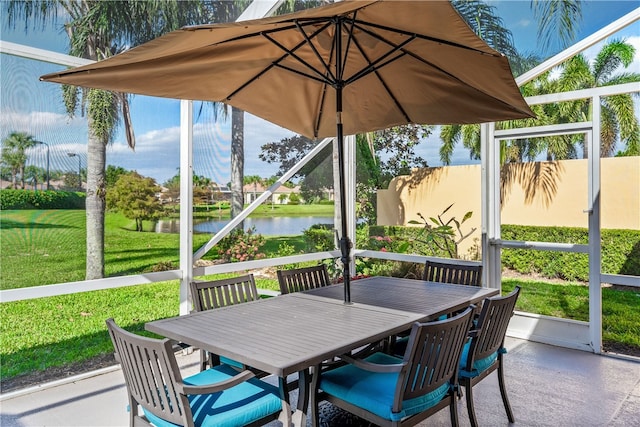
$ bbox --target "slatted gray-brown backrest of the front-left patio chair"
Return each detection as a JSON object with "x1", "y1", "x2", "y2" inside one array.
[{"x1": 107, "y1": 319, "x2": 193, "y2": 426}]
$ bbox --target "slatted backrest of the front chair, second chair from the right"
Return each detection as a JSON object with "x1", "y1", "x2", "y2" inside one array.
[{"x1": 394, "y1": 308, "x2": 473, "y2": 410}]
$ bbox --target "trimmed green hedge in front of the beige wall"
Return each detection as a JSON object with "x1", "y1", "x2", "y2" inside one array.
[{"x1": 501, "y1": 225, "x2": 640, "y2": 282}]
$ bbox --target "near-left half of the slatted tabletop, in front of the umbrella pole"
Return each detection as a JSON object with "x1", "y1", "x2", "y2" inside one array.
[{"x1": 146, "y1": 293, "x2": 424, "y2": 377}]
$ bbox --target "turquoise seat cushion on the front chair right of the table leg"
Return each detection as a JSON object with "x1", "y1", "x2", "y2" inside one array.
[{"x1": 320, "y1": 353, "x2": 451, "y2": 421}]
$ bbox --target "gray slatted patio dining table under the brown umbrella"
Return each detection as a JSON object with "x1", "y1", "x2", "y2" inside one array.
[{"x1": 145, "y1": 277, "x2": 498, "y2": 426}]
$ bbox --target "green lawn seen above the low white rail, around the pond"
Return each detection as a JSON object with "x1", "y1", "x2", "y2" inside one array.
[{"x1": 0, "y1": 211, "x2": 320, "y2": 289}]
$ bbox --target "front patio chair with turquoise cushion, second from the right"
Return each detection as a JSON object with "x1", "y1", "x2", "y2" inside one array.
[{"x1": 311, "y1": 308, "x2": 472, "y2": 426}]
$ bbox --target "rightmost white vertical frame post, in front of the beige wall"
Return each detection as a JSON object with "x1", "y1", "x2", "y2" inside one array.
[{"x1": 585, "y1": 95, "x2": 602, "y2": 354}]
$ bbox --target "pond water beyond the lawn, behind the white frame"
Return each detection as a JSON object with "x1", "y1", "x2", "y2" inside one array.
[{"x1": 155, "y1": 216, "x2": 333, "y2": 236}]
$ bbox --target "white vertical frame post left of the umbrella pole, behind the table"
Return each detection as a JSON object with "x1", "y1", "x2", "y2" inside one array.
[{"x1": 180, "y1": 100, "x2": 193, "y2": 314}]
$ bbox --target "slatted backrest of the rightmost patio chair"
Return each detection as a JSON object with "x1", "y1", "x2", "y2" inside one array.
[{"x1": 467, "y1": 286, "x2": 520, "y2": 370}]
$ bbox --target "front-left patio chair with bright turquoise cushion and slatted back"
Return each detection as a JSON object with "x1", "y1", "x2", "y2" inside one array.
[{"x1": 107, "y1": 319, "x2": 290, "y2": 427}]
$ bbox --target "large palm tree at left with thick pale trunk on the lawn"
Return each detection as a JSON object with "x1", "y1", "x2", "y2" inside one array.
[{"x1": 6, "y1": 0, "x2": 208, "y2": 279}]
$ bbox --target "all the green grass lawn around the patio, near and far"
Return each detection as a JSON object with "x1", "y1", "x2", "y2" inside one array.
[{"x1": 0, "y1": 211, "x2": 640, "y2": 378}]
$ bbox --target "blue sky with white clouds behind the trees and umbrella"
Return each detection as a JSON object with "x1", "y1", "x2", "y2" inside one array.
[{"x1": 0, "y1": 0, "x2": 640, "y2": 183}]
